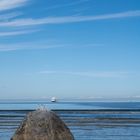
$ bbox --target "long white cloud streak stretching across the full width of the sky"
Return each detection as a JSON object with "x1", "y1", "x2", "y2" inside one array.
[{"x1": 0, "y1": 10, "x2": 140, "y2": 27}]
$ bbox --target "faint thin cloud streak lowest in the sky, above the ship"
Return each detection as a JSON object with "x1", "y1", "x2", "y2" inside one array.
[{"x1": 39, "y1": 71, "x2": 132, "y2": 78}]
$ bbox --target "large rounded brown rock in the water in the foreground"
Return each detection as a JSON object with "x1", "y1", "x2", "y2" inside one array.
[{"x1": 11, "y1": 110, "x2": 74, "y2": 140}]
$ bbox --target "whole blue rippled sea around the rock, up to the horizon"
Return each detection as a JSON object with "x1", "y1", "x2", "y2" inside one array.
[{"x1": 0, "y1": 100, "x2": 140, "y2": 140}]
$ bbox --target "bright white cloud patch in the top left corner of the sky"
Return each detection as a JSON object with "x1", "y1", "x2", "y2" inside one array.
[{"x1": 0, "y1": 0, "x2": 28, "y2": 11}]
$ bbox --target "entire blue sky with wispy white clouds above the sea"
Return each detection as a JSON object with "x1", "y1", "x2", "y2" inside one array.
[{"x1": 0, "y1": 0, "x2": 140, "y2": 99}]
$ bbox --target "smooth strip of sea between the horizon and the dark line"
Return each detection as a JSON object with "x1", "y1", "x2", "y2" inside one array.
[{"x1": 0, "y1": 100, "x2": 140, "y2": 110}]
